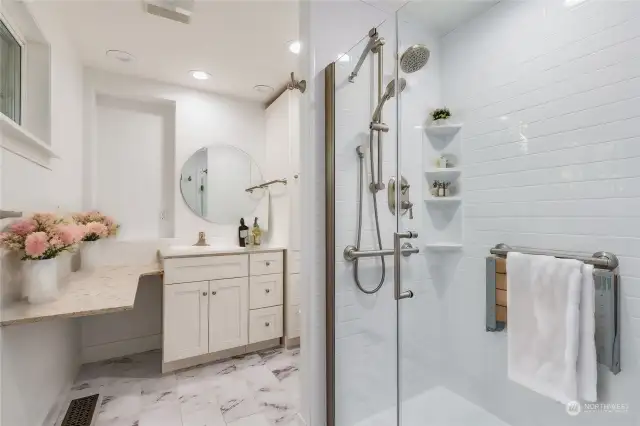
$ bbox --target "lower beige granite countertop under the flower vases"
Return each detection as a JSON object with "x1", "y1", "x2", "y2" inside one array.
[{"x1": 0, "y1": 263, "x2": 162, "y2": 326}]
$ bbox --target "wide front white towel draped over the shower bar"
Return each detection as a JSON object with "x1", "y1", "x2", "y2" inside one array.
[{"x1": 507, "y1": 253, "x2": 582, "y2": 404}]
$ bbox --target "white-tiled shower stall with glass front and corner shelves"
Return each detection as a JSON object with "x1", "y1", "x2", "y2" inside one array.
[{"x1": 319, "y1": 0, "x2": 640, "y2": 426}]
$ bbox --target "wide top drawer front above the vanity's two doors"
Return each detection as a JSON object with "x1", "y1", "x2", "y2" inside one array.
[{"x1": 164, "y1": 254, "x2": 249, "y2": 284}]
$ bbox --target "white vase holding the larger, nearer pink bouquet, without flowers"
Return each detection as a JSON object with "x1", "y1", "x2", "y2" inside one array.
[{"x1": 22, "y1": 258, "x2": 59, "y2": 303}]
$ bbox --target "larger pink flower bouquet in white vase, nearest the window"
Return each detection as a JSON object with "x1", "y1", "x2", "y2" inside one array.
[{"x1": 0, "y1": 213, "x2": 84, "y2": 303}]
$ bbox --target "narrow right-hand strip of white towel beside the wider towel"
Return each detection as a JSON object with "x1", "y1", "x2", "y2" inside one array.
[{"x1": 578, "y1": 264, "x2": 598, "y2": 402}]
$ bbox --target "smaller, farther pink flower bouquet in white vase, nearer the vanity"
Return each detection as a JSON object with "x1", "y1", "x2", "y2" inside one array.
[{"x1": 73, "y1": 211, "x2": 120, "y2": 270}]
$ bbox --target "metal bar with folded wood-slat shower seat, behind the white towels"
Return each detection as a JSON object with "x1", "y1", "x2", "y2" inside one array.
[{"x1": 486, "y1": 244, "x2": 620, "y2": 374}]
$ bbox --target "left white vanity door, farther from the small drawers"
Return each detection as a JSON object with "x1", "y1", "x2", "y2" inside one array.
[{"x1": 163, "y1": 281, "x2": 209, "y2": 362}]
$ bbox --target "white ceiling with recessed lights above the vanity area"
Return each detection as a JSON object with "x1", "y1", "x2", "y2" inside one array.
[{"x1": 37, "y1": 0, "x2": 299, "y2": 101}]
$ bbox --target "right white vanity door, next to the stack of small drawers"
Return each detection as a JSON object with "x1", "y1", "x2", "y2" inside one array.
[{"x1": 209, "y1": 277, "x2": 249, "y2": 352}]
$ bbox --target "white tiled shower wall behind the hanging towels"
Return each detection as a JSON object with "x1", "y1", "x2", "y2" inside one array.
[{"x1": 440, "y1": 1, "x2": 640, "y2": 426}]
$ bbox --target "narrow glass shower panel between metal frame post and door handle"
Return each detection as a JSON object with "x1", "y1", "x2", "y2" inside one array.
[{"x1": 327, "y1": 15, "x2": 398, "y2": 426}]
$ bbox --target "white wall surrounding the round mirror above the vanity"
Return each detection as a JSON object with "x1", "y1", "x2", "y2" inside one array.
[{"x1": 85, "y1": 69, "x2": 265, "y2": 244}]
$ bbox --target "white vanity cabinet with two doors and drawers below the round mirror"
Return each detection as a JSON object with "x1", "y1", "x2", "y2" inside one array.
[{"x1": 163, "y1": 250, "x2": 285, "y2": 364}]
